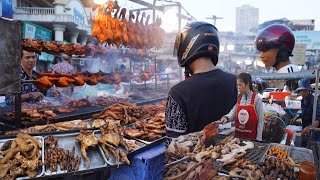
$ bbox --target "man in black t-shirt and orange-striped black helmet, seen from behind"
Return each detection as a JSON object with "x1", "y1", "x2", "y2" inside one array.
[{"x1": 165, "y1": 22, "x2": 237, "y2": 138}]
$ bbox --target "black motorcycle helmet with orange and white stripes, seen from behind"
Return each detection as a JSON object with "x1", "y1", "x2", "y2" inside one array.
[{"x1": 173, "y1": 22, "x2": 219, "y2": 67}]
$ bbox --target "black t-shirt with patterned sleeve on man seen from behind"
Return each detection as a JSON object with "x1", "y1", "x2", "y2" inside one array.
[{"x1": 166, "y1": 69, "x2": 237, "y2": 137}]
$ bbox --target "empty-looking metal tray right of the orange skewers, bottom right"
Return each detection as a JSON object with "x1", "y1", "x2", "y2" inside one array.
[{"x1": 290, "y1": 147, "x2": 314, "y2": 164}]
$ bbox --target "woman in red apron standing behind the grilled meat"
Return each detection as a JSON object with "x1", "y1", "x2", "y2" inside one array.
[{"x1": 221, "y1": 73, "x2": 264, "y2": 140}]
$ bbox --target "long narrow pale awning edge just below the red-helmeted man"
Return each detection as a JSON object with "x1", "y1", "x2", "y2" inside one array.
[{"x1": 251, "y1": 70, "x2": 316, "y2": 80}]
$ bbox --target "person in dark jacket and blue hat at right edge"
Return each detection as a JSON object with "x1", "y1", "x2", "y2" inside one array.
[{"x1": 291, "y1": 79, "x2": 320, "y2": 147}]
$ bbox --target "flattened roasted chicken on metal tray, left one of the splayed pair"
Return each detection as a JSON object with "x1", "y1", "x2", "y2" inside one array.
[{"x1": 76, "y1": 130, "x2": 99, "y2": 169}]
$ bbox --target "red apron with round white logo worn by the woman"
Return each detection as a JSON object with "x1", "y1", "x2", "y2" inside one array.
[{"x1": 235, "y1": 93, "x2": 259, "y2": 139}]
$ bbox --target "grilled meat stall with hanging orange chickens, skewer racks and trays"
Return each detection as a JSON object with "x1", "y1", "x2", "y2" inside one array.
[{"x1": 0, "y1": 1, "x2": 170, "y2": 179}]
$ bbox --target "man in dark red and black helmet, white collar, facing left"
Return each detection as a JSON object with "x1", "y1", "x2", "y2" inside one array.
[{"x1": 255, "y1": 24, "x2": 299, "y2": 73}]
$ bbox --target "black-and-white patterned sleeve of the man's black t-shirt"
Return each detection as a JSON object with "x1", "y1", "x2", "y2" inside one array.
[{"x1": 165, "y1": 95, "x2": 188, "y2": 138}]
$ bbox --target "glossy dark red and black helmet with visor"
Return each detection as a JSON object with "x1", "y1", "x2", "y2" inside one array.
[{"x1": 255, "y1": 24, "x2": 295, "y2": 67}]
